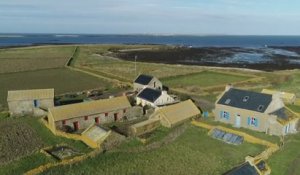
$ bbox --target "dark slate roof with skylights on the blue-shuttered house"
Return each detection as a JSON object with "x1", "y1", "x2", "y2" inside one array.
[{"x1": 218, "y1": 88, "x2": 272, "y2": 113}]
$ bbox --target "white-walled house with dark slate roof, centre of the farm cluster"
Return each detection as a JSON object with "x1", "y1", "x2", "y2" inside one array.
[{"x1": 136, "y1": 88, "x2": 175, "y2": 107}]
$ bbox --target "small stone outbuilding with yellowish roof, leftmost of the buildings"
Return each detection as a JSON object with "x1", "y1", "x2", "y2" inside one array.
[{"x1": 7, "y1": 89, "x2": 54, "y2": 116}]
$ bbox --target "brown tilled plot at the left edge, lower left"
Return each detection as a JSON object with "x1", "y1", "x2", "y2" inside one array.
[{"x1": 0, "y1": 120, "x2": 43, "y2": 165}]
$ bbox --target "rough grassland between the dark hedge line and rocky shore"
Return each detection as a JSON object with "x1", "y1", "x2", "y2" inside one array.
[{"x1": 74, "y1": 45, "x2": 205, "y2": 82}]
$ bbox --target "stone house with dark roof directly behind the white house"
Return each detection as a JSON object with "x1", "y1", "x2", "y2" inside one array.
[{"x1": 133, "y1": 74, "x2": 163, "y2": 92}]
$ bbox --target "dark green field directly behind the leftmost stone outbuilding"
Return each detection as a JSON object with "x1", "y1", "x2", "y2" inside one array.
[{"x1": 0, "y1": 68, "x2": 111, "y2": 106}]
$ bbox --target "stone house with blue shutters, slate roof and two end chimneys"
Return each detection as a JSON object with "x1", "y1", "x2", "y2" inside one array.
[{"x1": 213, "y1": 86, "x2": 299, "y2": 135}]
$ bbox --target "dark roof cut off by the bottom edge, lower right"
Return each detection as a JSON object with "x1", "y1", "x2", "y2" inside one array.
[{"x1": 224, "y1": 162, "x2": 259, "y2": 175}]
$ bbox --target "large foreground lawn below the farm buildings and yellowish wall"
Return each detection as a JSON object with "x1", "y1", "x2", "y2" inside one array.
[{"x1": 44, "y1": 125, "x2": 264, "y2": 175}]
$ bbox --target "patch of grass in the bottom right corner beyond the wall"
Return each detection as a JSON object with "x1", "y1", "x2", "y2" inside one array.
[{"x1": 268, "y1": 133, "x2": 300, "y2": 175}]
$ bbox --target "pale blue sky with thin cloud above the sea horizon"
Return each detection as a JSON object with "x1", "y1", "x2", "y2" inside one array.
[{"x1": 0, "y1": 0, "x2": 300, "y2": 35}]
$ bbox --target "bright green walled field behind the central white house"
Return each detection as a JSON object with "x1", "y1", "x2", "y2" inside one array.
[{"x1": 162, "y1": 71, "x2": 250, "y2": 88}]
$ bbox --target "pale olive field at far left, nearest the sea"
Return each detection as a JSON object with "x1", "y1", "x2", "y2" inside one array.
[{"x1": 0, "y1": 46, "x2": 75, "y2": 74}]
